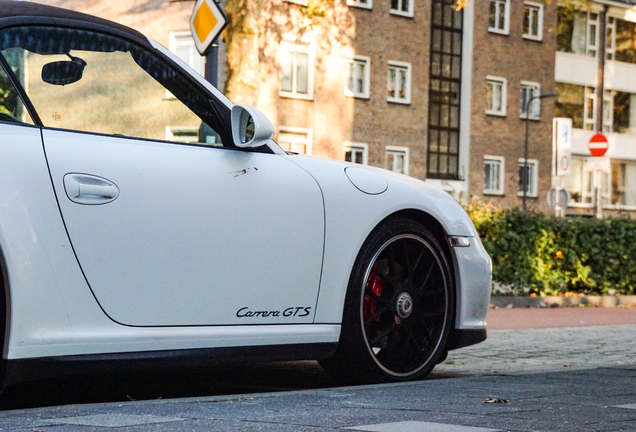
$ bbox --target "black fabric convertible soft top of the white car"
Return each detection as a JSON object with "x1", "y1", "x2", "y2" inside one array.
[{"x1": 0, "y1": 0, "x2": 150, "y2": 46}]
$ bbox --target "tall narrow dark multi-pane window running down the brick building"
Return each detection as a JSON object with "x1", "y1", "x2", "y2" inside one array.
[{"x1": 426, "y1": 0, "x2": 464, "y2": 180}]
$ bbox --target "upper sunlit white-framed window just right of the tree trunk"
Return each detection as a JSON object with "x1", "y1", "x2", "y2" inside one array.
[{"x1": 280, "y1": 41, "x2": 314, "y2": 99}]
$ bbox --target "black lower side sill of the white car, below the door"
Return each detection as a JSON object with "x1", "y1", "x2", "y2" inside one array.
[{"x1": 0, "y1": 342, "x2": 338, "y2": 390}]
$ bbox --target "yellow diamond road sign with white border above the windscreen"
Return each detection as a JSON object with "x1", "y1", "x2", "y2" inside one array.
[{"x1": 190, "y1": 0, "x2": 228, "y2": 55}]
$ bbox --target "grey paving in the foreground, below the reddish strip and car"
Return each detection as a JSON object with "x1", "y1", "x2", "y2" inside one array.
[{"x1": 0, "y1": 325, "x2": 636, "y2": 432}]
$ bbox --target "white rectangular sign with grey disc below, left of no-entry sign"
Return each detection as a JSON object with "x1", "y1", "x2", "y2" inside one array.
[{"x1": 548, "y1": 118, "x2": 572, "y2": 217}]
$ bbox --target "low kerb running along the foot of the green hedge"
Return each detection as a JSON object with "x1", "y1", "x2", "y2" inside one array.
[{"x1": 490, "y1": 295, "x2": 636, "y2": 309}]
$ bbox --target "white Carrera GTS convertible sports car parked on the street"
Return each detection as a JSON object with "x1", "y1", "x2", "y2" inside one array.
[{"x1": 0, "y1": 0, "x2": 491, "y2": 386}]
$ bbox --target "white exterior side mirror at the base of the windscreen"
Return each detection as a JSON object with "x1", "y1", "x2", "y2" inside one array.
[{"x1": 232, "y1": 105, "x2": 274, "y2": 148}]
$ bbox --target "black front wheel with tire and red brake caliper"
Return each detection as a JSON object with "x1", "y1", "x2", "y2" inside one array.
[{"x1": 320, "y1": 218, "x2": 455, "y2": 383}]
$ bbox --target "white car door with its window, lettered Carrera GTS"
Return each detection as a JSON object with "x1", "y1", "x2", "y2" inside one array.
[{"x1": 9, "y1": 25, "x2": 324, "y2": 326}]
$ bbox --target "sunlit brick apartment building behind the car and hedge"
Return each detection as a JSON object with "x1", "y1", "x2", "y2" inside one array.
[{"x1": 28, "y1": 0, "x2": 636, "y2": 212}]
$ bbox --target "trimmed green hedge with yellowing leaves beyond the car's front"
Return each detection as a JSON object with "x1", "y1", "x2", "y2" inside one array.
[{"x1": 467, "y1": 201, "x2": 636, "y2": 295}]
